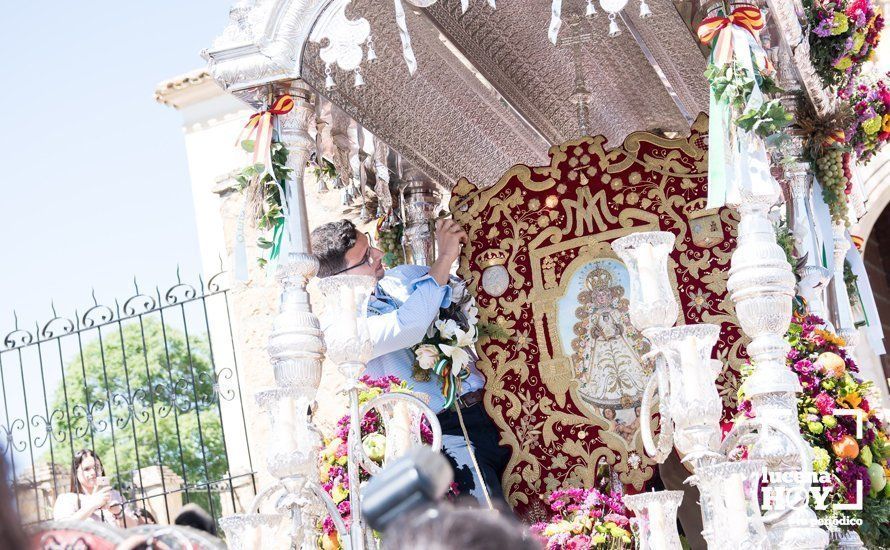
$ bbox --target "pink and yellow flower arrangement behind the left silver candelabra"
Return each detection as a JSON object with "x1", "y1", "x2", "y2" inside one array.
[{"x1": 318, "y1": 375, "x2": 458, "y2": 550}]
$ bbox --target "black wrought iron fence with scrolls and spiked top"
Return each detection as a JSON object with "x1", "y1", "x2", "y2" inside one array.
[{"x1": 0, "y1": 272, "x2": 256, "y2": 523}]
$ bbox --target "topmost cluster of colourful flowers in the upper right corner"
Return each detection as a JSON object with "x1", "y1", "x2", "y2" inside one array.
[{"x1": 804, "y1": 0, "x2": 884, "y2": 92}]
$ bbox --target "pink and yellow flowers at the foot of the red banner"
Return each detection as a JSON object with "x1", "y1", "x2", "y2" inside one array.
[{"x1": 530, "y1": 488, "x2": 633, "y2": 550}]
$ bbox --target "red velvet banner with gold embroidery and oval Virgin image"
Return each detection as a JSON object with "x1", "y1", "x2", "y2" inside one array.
[{"x1": 451, "y1": 116, "x2": 743, "y2": 521}]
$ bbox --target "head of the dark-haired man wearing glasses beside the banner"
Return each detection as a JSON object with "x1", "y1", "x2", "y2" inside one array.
[{"x1": 311, "y1": 220, "x2": 384, "y2": 280}]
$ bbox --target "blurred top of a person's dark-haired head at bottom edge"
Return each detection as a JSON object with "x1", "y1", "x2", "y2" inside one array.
[{"x1": 383, "y1": 506, "x2": 541, "y2": 550}]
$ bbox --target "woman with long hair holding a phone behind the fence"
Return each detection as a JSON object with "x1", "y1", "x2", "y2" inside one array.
[{"x1": 53, "y1": 449, "x2": 144, "y2": 527}]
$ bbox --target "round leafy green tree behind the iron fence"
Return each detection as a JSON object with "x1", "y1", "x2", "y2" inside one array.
[{"x1": 52, "y1": 318, "x2": 228, "y2": 514}]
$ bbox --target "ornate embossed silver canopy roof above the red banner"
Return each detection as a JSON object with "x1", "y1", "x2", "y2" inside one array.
[{"x1": 205, "y1": 0, "x2": 707, "y2": 188}]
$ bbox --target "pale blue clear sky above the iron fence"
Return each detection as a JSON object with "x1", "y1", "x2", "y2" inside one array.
[{"x1": 0, "y1": 0, "x2": 229, "y2": 336}]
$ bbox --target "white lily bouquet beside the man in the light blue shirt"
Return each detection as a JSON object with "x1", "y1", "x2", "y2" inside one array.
[{"x1": 413, "y1": 278, "x2": 507, "y2": 409}]
